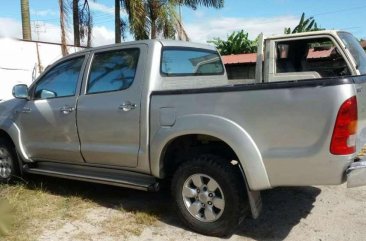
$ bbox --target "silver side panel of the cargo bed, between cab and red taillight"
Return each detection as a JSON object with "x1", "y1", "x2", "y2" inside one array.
[{"x1": 150, "y1": 80, "x2": 355, "y2": 189}]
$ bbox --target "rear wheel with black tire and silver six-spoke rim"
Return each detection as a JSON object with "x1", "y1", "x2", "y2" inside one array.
[{"x1": 171, "y1": 155, "x2": 248, "y2": 237}]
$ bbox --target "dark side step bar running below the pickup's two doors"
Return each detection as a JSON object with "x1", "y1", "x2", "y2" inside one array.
[{"x1": 23, "y1": 162, "x2": 159, "y2": 191}]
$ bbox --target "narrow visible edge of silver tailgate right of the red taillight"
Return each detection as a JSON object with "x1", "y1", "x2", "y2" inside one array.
[{"x1": 354, "y1": 75, "x2": 366, "y2": 153}]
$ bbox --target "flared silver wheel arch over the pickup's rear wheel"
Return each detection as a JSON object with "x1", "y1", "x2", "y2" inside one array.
[{"x1": 150, "y1": 114, "x2": 271, "y2": 190}]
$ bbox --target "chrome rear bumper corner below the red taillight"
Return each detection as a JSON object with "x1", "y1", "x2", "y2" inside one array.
[{"x1": 346, "y1": 160, "x2": 366, "y2": 188}]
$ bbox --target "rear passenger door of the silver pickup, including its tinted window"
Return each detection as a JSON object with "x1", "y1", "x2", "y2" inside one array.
[{"x1": 77, "y1": 45, "x2": 147, "y2": 167}]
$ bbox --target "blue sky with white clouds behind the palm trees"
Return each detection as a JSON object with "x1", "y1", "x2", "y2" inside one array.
[{"x1": 0, "y1": 0, "x2": 366, "y2": 46}]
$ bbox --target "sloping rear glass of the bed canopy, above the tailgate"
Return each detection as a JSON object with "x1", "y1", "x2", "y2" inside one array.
[{"x1": 338, "y1": 33, "x2": 366, "y2": 74}]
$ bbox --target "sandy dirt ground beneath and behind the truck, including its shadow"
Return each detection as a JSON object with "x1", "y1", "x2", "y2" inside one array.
[{"x1": 0, "y1": 177, "x2": 366, "y2": 241}]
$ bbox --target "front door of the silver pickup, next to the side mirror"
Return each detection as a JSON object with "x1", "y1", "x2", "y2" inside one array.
[{"x1": 16, "y1": 56, "x2": 85, "y2": 162}]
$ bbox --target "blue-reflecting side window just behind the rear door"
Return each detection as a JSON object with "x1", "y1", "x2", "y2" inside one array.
[{"x1": 160, "y1": 47, "x2": 225, "y2": 77}]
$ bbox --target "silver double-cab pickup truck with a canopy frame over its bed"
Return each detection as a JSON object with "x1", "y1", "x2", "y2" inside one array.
[{"x1": 0, "y1": 31, "x2": 366, "y2": 236}]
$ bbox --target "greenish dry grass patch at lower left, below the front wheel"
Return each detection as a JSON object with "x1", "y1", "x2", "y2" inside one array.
[{"x1": 0, "y1": 183, "x2": 95, "y2": 241}]
